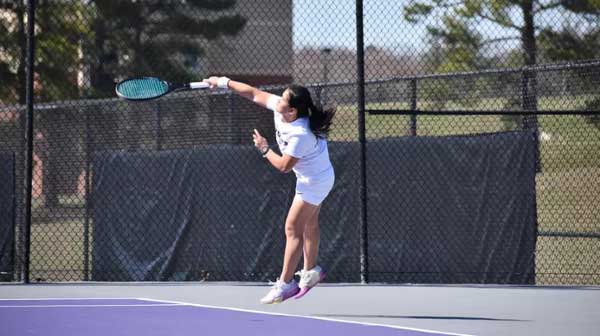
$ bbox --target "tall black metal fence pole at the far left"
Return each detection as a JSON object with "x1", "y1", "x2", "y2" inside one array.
[{"x1": 22, "y1": 0, "x2": 35, "y2": 283}]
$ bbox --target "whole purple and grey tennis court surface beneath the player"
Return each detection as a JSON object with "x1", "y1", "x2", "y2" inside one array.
[{"x1": 0, "y1": 283, "x2": 600, "y2": 336}]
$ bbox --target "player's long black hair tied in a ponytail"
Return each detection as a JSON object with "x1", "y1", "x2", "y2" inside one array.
[{"x1": 287, "y1": 85, "x2": 335, "y2": 138}]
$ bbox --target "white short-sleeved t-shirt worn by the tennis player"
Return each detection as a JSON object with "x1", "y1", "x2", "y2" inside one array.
[{"x1": 267, "y1": 95, "x2": 333, "y2": 182}]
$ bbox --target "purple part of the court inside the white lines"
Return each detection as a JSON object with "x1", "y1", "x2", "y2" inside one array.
[{"x1": 0, "y1": 299, "x2": 468, "y2": 336}]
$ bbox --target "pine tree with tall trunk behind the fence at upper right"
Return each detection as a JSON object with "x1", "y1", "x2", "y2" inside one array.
[{"x1": 404, "y1": 0, "x2": 600, "y2": 134}]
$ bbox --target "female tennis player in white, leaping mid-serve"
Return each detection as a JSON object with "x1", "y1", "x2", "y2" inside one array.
[{"x1": 204, "y1": 77, "x2": 335, "y2": 304}]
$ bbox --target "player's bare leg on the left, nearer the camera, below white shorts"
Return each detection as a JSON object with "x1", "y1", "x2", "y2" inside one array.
[{"x1": 279, "y1": 197, "x2": 319, "y2": 282}]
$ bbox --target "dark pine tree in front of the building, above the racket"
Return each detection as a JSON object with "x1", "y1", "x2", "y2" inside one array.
[{"x1": 85, "y1": 0, "x2": 246, "y2": 96}]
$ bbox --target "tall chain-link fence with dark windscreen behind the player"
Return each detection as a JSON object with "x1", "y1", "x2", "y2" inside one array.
[{"x1": 0, "y1": 0, "x2": 600, "y2": 285}]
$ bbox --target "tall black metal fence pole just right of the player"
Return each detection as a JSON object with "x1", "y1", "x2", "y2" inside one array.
[{"x1": 356, "y1": 0, "x2": 369, "y2": 283}]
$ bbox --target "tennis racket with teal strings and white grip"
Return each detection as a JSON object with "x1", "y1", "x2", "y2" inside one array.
[{"x1": 115, "y1": 77, "x2": 209, "y2": 100}]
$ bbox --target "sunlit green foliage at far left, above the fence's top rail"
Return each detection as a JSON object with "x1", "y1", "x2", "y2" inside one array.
[{"x1": 0, "y1": 0, "x2": 85, "y2": 104}]
